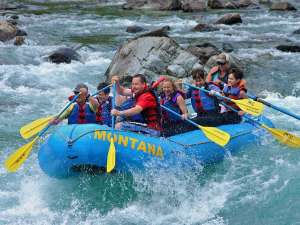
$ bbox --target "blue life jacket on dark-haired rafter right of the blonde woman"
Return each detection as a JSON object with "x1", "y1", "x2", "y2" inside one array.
[{"x1": 189, "y1": 83, "x2": 220, "y2": 113}]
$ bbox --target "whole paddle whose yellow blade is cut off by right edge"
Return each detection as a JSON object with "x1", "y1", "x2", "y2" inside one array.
[{"x1": 221, "y1": 102, "x2": 300, "y2": 148}]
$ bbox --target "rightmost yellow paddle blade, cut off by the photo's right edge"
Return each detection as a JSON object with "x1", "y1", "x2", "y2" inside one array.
[{"x1": 262, "y1": 124, "x2": 300, "y2": 149}]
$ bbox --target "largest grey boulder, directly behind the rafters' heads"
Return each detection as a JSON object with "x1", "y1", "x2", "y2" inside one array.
[{"x1": 106, "y1": 36, "x2": 199, "y2": 80}]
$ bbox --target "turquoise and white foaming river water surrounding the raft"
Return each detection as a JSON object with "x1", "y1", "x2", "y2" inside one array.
[{"x1": 0, "y1": 0, "x2": 300, "y2": 225}]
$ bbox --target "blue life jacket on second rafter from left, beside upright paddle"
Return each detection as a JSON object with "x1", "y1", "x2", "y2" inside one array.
[{"x1": 96, "y1": 96, "x2": 112, "y2": 127}]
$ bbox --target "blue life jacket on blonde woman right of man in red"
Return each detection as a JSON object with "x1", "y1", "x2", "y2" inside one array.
[{"x1": 160, "y1": 91, "x2": 182, "y2": 122}]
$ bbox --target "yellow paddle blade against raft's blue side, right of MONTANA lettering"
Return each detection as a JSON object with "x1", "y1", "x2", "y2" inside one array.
[{"x1": 198, "y1": 125, "x2": 230, "y2": 146}]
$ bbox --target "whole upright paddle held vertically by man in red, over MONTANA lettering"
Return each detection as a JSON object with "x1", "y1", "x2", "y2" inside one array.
[{"x1": 106, "y1": 82, "x2": 116, "y2": 173}]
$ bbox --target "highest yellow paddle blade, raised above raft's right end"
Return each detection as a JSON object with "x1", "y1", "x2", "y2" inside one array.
[{"x1": 231, "y1": 98, "x2": 264, "y2": 116}]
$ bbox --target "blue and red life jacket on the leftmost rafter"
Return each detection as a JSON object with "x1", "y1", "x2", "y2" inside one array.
[{"x1": 68, "y1": 103, "x2": 96, "y2": 124}]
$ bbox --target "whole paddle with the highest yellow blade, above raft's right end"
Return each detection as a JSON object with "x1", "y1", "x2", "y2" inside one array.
[{"x1": 184, "y1": 83, "x2": 264, "y2": 116}]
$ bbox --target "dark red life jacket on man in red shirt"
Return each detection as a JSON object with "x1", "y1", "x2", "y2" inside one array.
[{"x1": 134, "y1": 89, "x2": 161, "y2": 131}]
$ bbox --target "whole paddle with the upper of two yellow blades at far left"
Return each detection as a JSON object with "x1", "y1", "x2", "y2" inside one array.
[{"x1": 20, "y1": 85, "x2": 111, "y2": 139}]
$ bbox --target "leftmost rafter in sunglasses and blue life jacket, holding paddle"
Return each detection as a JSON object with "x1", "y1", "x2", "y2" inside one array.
[{"x1": 51, "y1": 83, "x2": 99, "y2": 124}]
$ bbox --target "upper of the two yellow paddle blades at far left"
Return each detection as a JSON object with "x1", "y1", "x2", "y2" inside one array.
[{"x1": 20, "y1": 116, "x2": 53, "y2": 139}]
